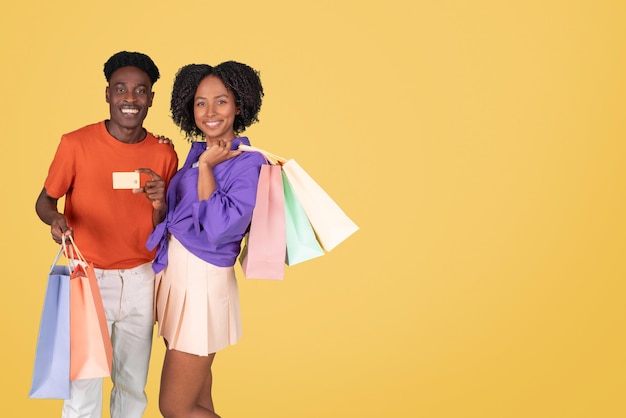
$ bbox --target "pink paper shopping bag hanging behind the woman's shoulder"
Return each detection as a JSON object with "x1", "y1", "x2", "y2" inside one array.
[{"x1": 239, "y1": 164, "x2": 287, "y2": 280}]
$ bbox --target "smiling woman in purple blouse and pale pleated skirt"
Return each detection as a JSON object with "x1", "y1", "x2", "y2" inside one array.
[{"x1": 148, "y1": 61, "x2": 265, "y2": 418}]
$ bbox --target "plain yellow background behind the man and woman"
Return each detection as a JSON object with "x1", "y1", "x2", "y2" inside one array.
[{"x1": 0, "y1": 0, "x2": 626, "y2": 418}]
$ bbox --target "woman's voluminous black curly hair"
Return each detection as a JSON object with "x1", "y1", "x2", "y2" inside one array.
[{"x1": 170, "y1": 61, "x2": 263, "y2": 141}]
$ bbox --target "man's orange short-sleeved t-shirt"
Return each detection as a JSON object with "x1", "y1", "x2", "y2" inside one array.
[{"x1": 44, "y1": 121, "x2": 178, "y2": 269}]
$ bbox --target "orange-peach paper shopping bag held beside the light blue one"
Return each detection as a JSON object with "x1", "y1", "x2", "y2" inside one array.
[{"x1": 70, "y1": 240, "x2": 113, "y2": 380}]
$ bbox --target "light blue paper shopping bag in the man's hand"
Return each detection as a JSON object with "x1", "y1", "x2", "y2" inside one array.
[{"x1": 28, "y1": 246, "x2": 70, "y2": 399}]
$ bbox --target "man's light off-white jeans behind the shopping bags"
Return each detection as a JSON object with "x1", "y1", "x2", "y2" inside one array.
[{"x1": 62, "y1": 263, "x2": 154, "y2": 418}]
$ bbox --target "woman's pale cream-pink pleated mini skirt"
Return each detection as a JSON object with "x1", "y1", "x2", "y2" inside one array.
[{"x1": 154, "y1": 236, "x2": 241, "y2": 356}]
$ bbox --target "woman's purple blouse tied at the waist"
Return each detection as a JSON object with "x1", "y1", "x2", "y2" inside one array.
[{"x1": 146, "y1": 137, "x2": 267, "y2": 273}]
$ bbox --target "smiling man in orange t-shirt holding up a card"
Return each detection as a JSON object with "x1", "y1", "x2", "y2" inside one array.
[{"x1": 35, "y1": 51, "x2": 178, "y2": 418}]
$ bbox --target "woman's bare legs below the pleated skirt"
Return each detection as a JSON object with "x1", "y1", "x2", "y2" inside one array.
[{"x1": 159, "y1": 350, "x2": 219, "y2": 418}]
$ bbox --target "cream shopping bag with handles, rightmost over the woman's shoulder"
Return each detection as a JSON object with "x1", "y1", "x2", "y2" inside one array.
[{"x1": 239, "y1": 144, "x2": 359, "y2": 251}]
